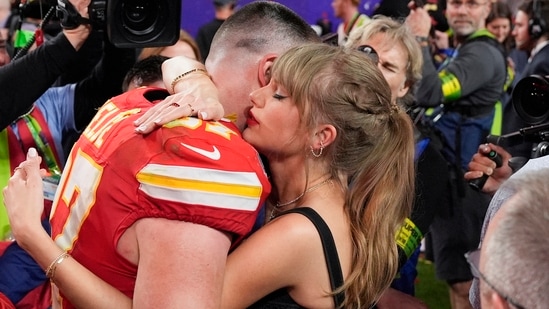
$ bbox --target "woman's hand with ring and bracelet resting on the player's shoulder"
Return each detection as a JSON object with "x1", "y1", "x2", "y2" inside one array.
[{"x1": 134, "y1": 57, "x2": 224, "y2": 134}]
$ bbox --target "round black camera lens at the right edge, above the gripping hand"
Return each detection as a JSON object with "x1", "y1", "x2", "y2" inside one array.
[{"x1": 513, "y1": 75, "x2": 549, "y2": 125}]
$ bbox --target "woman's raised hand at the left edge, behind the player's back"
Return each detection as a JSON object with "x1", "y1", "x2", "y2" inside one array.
[{"x1": 3, "y1": 148, "x2": 47, "y2": 249}]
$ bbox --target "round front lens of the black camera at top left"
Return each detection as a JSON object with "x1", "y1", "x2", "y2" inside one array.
[{"x1": 122, "y1": 0, "x2": 160, "y2": 35}]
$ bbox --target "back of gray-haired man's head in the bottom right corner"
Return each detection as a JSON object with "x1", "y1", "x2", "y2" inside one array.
[{"x1": 467, "y1": 168, "x2": 549, "y2": 308}]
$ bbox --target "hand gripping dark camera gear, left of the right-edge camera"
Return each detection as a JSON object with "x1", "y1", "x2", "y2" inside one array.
[{"x1": 464, "y1": 144, "x2": 513, "y2": 194}]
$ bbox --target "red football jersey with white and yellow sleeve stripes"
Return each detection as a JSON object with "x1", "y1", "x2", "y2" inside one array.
[{"x1": 51, "y1": 88, "x2": 270, "y2": 308}]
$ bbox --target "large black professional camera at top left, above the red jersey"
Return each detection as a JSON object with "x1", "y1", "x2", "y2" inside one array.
[{"x1": 57, "y1": 0, "x2": 181, "y2": 48}]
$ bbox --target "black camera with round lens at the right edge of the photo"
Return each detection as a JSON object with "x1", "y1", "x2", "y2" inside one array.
[{"x1": 488, "y1": 75, "x2": 549, "y2": 158}]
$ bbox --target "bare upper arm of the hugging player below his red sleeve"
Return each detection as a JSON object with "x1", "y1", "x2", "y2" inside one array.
[{"x1": 133, "y1": 218, "x2": 231, "y2": 308}]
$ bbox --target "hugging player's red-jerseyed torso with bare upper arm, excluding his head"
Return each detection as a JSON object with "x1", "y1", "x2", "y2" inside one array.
[{"x1": 51, "y1": 88, "x2": 270, "y2": 307}]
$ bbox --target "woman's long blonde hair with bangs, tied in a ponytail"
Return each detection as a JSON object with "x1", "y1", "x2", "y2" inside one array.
[{"x1": 273, "y1": 44, "x2": 414, "y2": 308}]
